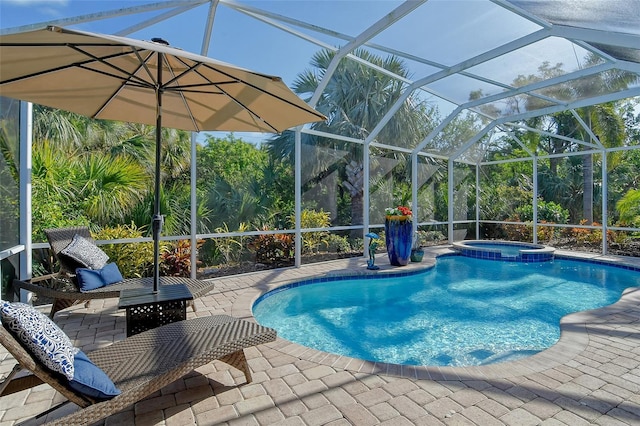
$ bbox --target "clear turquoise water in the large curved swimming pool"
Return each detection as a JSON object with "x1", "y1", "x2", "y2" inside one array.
[{"x1": 253, "y1": 256, "x2": 640, "y2": 366}]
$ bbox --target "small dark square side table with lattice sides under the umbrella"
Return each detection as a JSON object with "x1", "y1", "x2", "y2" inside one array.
[{"x1": 118, "y1": 284, "x2": 193, "y2": 337}]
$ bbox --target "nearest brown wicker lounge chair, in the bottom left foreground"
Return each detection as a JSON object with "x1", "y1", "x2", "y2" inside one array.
[{"x1": 0, "y1": 315, "x2": 276, "y2": 425}]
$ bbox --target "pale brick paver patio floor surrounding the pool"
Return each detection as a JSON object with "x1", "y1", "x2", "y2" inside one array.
[{"x1": 0, "y1": 247, "x2": 640, "y2": 426}]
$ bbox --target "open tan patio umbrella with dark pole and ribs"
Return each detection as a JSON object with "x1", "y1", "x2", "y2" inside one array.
[{"x1": 0, "y1": 26, "x2": 325, "y2": 291}]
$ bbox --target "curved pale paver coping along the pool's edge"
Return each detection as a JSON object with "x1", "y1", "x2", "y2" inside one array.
[{"x1": 231, "y1": 246, "x2": 640, "y2": 380}]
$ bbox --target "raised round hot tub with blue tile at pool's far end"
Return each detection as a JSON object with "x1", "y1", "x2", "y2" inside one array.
[{"x1": 453, "y1": 240, "x2": 556, "y2": 262}]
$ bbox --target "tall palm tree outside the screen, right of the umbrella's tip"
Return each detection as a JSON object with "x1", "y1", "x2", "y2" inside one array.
[{"x1": 267, "y1": 49, "x2": 426, "y2": 228}]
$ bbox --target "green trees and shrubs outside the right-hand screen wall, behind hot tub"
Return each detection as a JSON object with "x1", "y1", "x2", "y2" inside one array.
[{"x1": 472, "y1": 63, "x2": 640, "y2": 250}]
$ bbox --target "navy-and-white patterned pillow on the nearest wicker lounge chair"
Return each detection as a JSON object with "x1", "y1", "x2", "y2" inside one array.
[{"x1": 0, "y1": 301, "x2": 79, "y2": 380}]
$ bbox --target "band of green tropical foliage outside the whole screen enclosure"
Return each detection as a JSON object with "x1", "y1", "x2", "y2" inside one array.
[{"x1": 0, "y1": 49, "x2": 640, "y2": 282}]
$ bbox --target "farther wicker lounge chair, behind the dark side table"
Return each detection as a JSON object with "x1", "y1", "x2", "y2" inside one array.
[{"x1": 13, "y1": 226, "x2": 214, "y2": 318}]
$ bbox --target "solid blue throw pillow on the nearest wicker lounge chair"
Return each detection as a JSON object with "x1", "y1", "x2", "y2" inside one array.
[{"x1": 69, "y1": 351, "x2": 120, "y2": 399}]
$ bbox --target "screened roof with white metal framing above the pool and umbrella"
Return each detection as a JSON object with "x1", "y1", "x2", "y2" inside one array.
[{"x1": 1, "y1": 0, "x2": 640, "y2": 163}]
